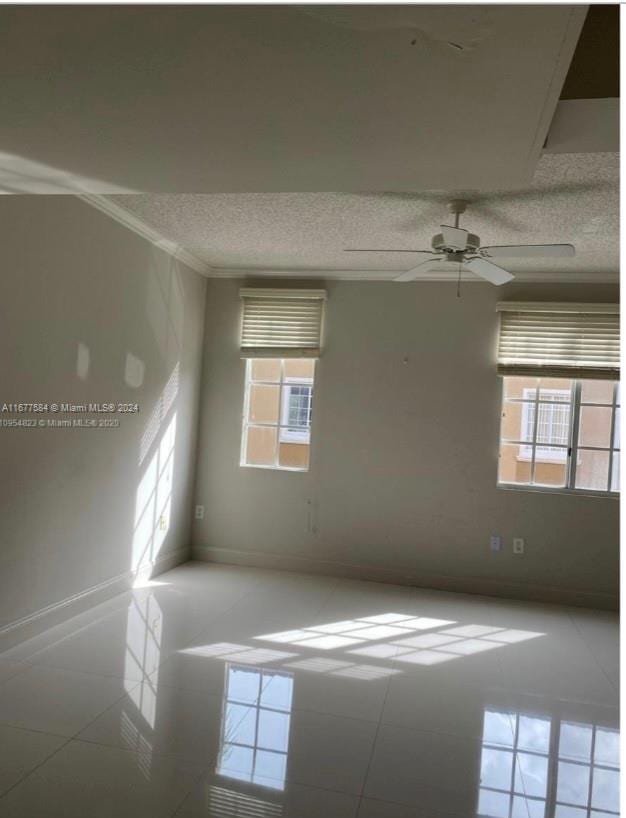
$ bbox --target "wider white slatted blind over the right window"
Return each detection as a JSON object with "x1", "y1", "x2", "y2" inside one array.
[{"x1": 496, "y1": 301, "x2": 620, "y2": 380}]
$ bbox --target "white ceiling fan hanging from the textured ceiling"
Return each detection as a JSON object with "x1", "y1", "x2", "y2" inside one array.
[{"x1": 344, "y1": 199, "x2": 575, "y2": 284}]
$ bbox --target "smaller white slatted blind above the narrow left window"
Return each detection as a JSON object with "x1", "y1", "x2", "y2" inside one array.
[{"x1": 240, "y1": 288, "x2": 326, "y2": 358}]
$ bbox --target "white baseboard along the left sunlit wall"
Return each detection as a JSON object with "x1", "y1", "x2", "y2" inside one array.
[{"x1": 0, "y1": 548, "x2": 189, "y2": 653}]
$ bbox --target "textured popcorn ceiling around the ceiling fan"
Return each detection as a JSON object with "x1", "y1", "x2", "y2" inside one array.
[{"x1": 109, "y1": 153, "x2": 619, "y2": 278}]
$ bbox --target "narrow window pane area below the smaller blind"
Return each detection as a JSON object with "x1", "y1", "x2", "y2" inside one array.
[{"x1": 241, "y1": 358, "x2": 315, "y2": 471}]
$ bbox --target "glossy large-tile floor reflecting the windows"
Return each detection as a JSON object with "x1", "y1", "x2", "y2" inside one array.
[{"x1": 0, "y1": 563, "x2": 619, "y2": 818}]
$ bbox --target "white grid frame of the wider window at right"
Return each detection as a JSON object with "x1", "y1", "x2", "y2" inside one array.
[{"x1": 496, "y1": 375, "x2": 621, "y2": 499}]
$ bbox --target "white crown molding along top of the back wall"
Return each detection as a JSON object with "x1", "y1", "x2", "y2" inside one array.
[{"x1": 208, "y1": 267, "x2": 619, "y2": 284}]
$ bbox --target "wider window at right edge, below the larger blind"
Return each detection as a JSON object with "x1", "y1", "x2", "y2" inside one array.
[{"x1": 498, "y1": 376, "x2": 620, "y2": 494}]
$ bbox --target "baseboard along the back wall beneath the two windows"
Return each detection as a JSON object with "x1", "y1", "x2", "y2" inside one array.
[{"x1": 191, "y1": 546, "x2": 619, "y2": 611}]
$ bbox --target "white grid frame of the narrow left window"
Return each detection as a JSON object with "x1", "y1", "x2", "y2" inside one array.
[{"x1": 239, "y1": 355, "x2": 318, "y2": 474}]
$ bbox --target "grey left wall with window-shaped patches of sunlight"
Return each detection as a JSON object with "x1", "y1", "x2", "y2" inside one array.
[{"x1": 0, "y1": 196, "x2": 206, "y2": 635}]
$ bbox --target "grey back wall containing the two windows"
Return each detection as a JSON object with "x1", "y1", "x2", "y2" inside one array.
[{"x1": 193, "y1": 280, "x2": 619, "y2": 606}]
